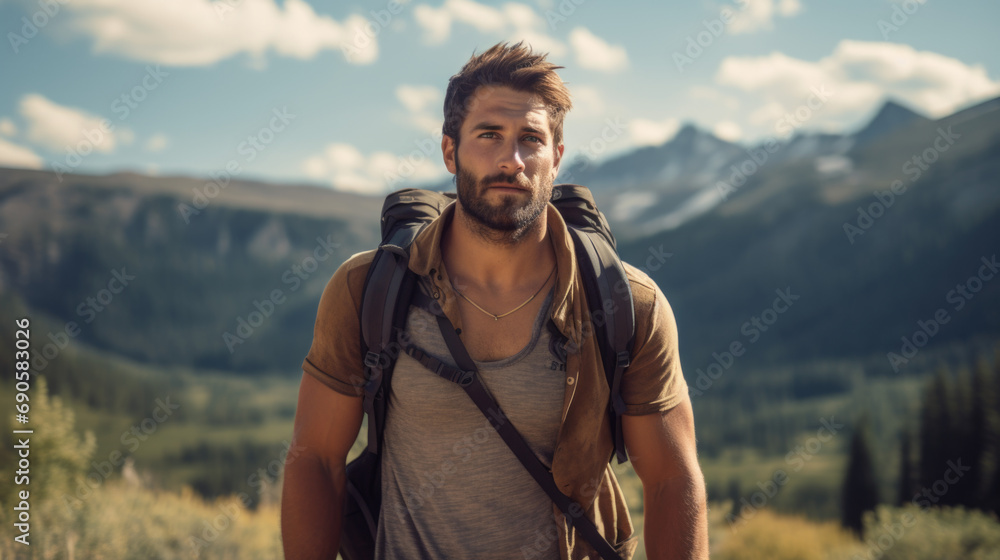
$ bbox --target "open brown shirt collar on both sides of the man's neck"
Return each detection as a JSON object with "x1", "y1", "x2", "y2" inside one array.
[{"x1": 409, "y1": 202, "x2": 582, "y2": 343}]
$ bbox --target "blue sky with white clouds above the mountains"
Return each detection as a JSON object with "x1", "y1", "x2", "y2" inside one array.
[{"x1": 0, "y1": 0, "x2": 1000, "y2": 193}]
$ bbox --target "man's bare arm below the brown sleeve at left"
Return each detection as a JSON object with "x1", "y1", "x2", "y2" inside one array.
[{"x1": 281, "y1": 374, "x2": 363, "y2": 560}]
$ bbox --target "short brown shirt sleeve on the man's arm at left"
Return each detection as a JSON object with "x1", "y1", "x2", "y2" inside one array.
[{"x1": 302, "y1": 251, "x2": 374, "y2": 397}]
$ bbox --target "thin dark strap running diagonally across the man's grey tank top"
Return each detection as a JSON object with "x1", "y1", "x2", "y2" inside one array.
[{"x1": 404, "y1": 290, "x2": 621, "y2": 560}]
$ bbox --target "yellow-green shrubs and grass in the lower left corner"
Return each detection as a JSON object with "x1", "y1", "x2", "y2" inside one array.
[{"x1": 0, "y1": 378, "x2": 282, "y2": 560}]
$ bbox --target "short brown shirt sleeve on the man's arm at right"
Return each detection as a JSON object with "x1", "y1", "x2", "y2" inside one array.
[{"x1": 622, "y1": 264, "x2": 688, "y2": 415}]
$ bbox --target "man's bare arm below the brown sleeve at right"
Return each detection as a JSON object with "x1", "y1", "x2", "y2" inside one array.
[{"x1": 622, "y1": 395, "x2": 708, "y2": 560}]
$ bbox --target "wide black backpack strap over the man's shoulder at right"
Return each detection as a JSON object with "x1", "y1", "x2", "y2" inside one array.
[{"x1": 552, "y1": 184, "x2": 635, "y2": 463}]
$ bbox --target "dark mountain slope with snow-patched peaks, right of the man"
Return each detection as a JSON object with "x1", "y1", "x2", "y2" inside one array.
[{"x1": 616, "y1": 94, "x2": 1000, "y2": 373}]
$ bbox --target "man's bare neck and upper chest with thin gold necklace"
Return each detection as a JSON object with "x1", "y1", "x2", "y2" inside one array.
[{"x1": 441, "y1": 203, "x2": 556, "y2": 294}]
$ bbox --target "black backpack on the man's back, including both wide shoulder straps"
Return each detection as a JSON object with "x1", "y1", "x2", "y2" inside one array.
[{"x1": 340, "y1": 184, "x2": 635, "y2": 560}]
